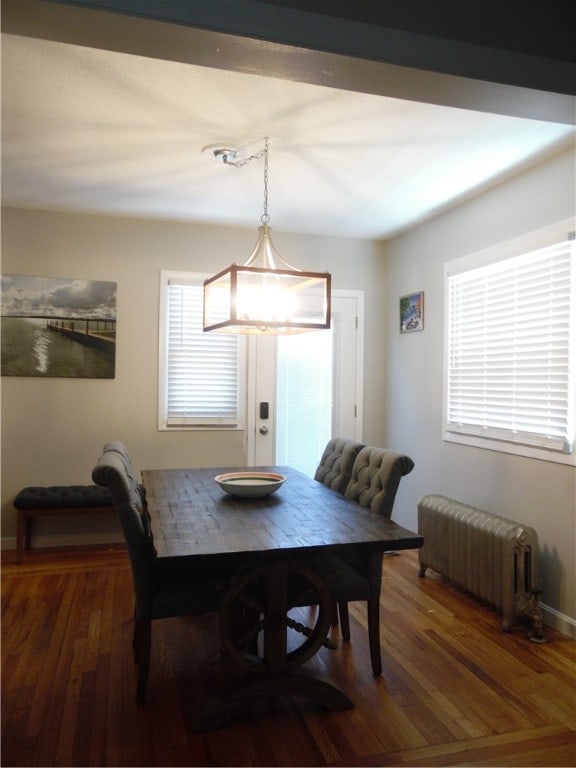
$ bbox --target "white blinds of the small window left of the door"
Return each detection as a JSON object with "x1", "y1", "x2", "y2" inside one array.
[{"x1": 159, "y1": 272, "x2": 244, "y2": 429}]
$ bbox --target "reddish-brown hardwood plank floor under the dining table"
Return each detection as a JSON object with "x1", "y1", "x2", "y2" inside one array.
[{"x1": 2, "y1": 549, "x2": 576, "y2": 766}]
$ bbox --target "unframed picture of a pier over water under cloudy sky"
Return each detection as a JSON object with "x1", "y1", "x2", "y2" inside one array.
[{"x1": 0, "y1": 275, "x2": 116, "y2": 379}]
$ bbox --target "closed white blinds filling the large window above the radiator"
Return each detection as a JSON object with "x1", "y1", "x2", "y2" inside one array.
[{"x1": 444, "y1": 222, "x2": 576, "y2": 463}]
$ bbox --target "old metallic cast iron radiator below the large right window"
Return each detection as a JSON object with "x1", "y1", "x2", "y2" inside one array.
[{"x1": 418, "y1": 495, "x2": 544, "y2": 642}]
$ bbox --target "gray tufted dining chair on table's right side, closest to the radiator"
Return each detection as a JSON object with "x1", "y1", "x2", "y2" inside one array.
[{"x1": 337, "y1": 446, "x2": 414, "y2": 675}]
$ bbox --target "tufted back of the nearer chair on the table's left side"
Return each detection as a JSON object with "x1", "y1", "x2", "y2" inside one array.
[{"x1": 92, "y1": 450, "x2": 156, "y2": 618}]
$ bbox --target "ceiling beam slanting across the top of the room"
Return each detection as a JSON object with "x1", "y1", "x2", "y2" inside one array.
[{"x1": 2, "y1": 0, "x2": 576, "y2": 124}]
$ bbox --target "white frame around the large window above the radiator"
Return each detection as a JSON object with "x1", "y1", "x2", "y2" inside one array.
[{"x1": 442, "y1": 219, "x2": 576, "y2": 466}]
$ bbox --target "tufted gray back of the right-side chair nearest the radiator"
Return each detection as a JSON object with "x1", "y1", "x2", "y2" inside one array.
[{"x1": 345, "y1": 446, "x2": 414, "y2": 517}]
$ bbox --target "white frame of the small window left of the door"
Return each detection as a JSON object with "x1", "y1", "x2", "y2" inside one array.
[{"x1": 158, "y1": 270, "x2": 247, "y2": 432}]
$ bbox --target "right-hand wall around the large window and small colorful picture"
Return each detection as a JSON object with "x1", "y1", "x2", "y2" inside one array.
[{"x1": 383, "y1": 144, "x2": 576, "y2": 631}]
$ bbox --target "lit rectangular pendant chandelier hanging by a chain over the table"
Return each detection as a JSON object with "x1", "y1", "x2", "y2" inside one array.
[{"x1": 203, "y1": 137, "x2": 330, "y2": 334}]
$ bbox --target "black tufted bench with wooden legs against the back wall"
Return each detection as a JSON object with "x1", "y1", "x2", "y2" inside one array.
[{"x1": 14, "y1": 485, "x2": 115, "y2": 563}]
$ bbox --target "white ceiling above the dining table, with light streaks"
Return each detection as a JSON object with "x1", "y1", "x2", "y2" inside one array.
[{"x1": 2, "y1": 0, "x2": 576, "y2": 238}]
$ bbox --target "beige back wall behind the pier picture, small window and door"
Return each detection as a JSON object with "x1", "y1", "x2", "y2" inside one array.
[{"x1": 1, "y1": 208, "x2": 385, "y2": 546}]
